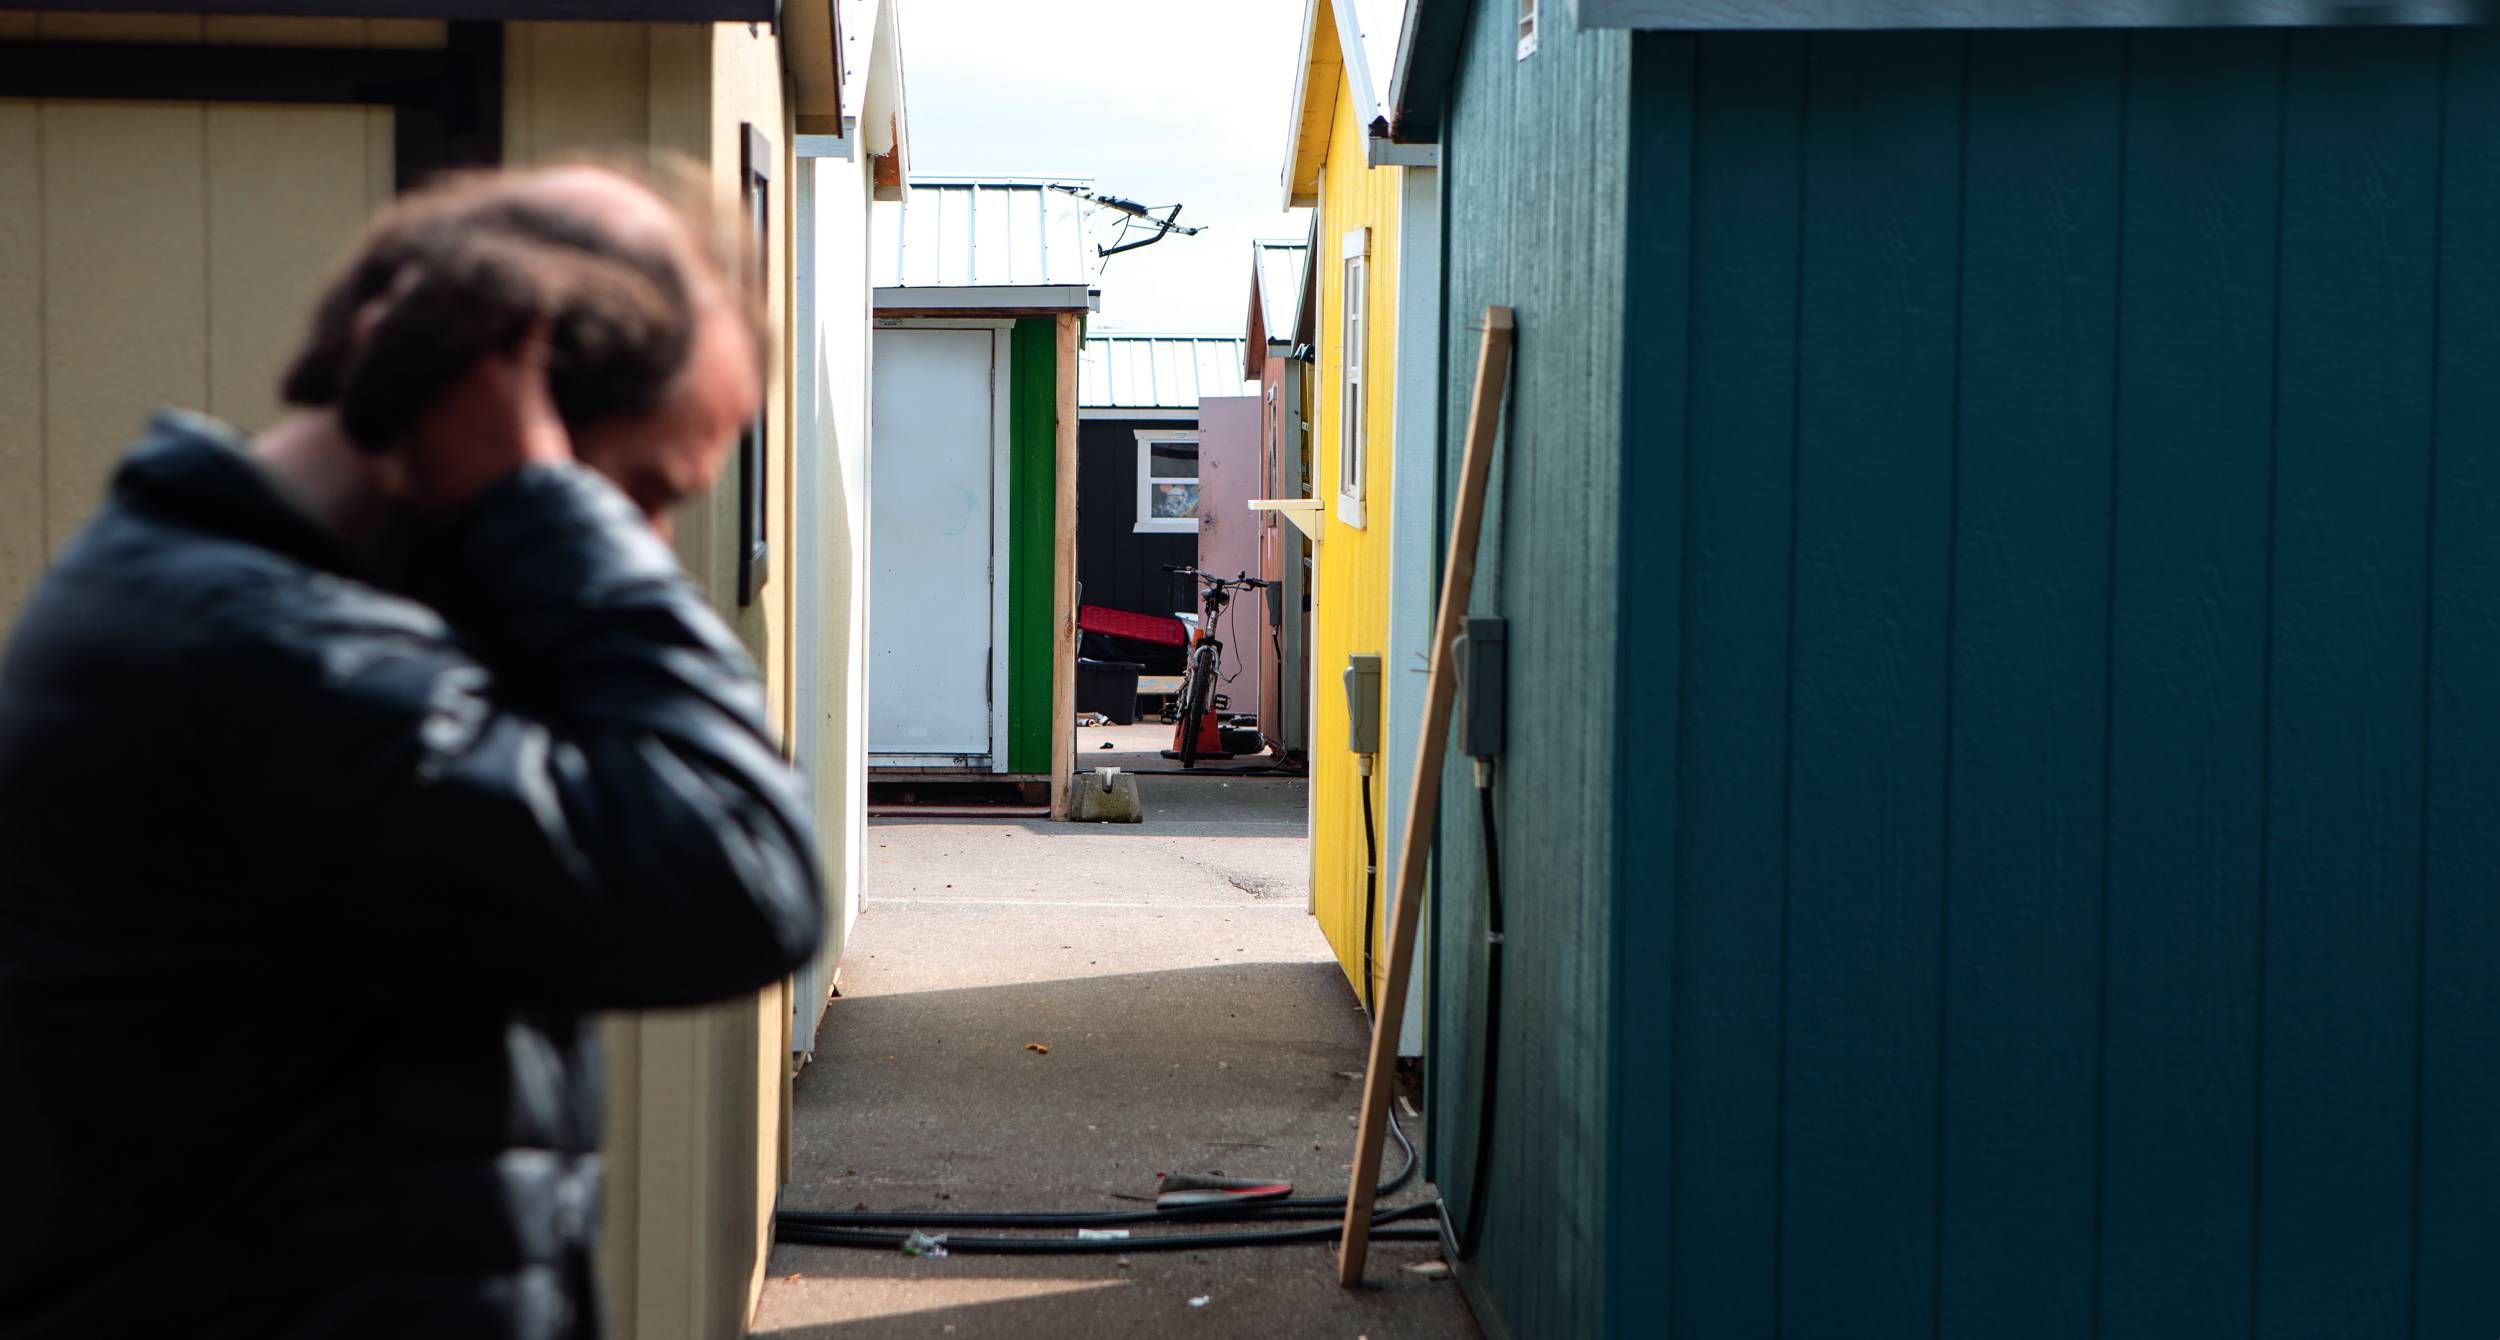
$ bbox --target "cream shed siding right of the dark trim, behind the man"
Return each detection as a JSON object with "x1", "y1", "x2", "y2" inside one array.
[{"x1": 505, "y1": 23, "x2": 795, "y2": 1340}]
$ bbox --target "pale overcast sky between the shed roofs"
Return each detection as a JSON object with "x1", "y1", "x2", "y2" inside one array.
[{"x1": 903, "y1": 0, "x2": 1308, "y2": 335}]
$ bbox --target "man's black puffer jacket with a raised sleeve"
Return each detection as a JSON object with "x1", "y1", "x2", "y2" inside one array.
[{"x1": 0, "y1": 415, "x2": 823, "y2": 1338}]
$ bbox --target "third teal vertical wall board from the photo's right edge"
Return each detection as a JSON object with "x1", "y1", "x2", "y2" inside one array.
[{"x1": 2098, "y1": 33, "x2": 2283, "y2": 1335}]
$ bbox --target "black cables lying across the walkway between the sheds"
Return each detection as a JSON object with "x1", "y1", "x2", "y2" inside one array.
[{"x1": 773, "y1": 1105, "x2": 1443, "y2": 1255}]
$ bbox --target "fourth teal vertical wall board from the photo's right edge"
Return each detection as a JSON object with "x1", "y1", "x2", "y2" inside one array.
[{"x1": 1938, "y1": 33, "x2": 2125, "y2": 1340}]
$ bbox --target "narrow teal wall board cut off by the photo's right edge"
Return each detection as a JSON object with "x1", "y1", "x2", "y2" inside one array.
[{"x1": 2415, "y1": 30, "x2": 2500, "y2": 1335}]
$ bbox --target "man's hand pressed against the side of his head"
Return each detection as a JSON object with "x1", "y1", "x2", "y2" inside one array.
[{"x1": 383, "y1": 323, "x2": 573, "y2": 518}]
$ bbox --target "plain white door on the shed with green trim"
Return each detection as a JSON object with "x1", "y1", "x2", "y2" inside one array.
[{"x1": 868, "y1": 328, "x2": 1008, "y2": 765}]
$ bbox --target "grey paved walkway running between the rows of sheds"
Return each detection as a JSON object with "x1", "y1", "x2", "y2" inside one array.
[{"x1": 755, "y1": 778, "x2": 1475, "y2": 1340}]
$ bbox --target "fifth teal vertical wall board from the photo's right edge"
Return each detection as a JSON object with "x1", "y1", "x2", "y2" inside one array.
[{"x1": 1780, "y1": 35, "x2": 1970, "y2": 1335}]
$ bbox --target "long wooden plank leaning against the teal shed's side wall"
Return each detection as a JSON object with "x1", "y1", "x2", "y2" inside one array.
[{"x1": 1338, "y1": 308, "x2": 1513, "y2": 1288}]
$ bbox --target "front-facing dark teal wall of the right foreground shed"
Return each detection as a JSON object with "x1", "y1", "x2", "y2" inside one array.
[{"x1": 1613, "y1": 30, "x2": 2500, "y2": 1335}]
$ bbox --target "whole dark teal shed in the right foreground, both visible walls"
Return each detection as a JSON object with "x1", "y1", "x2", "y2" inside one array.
[{"x1": 1375, "y1": 0, "x2": 2500, "y2": 1340}]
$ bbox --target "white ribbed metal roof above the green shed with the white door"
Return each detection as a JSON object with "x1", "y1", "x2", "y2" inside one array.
[{"x1": 870, "y1": 178, "x2": 1100, "y2": 310}]
